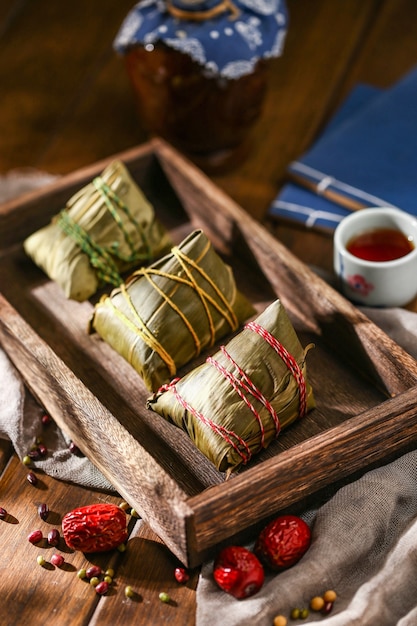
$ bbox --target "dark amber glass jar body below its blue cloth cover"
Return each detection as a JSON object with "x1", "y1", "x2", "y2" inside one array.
[{"x1": 124, "y1": 41, "x2": 267, "y2": 171}]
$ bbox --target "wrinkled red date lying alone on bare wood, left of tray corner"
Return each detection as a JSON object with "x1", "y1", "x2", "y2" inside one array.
[{"x1": 62, "y1": 503, "x2": 128, "y2": 553}]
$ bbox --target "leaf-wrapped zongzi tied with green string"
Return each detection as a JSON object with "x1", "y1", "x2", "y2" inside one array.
[{"x1": 24, "y1": 161, "x2": 172, "y2": 302}]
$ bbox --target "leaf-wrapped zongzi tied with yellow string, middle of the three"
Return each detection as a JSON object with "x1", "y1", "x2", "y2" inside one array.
[{"x1": 90, "y1": 230, "x2": 255, "y2": 391}]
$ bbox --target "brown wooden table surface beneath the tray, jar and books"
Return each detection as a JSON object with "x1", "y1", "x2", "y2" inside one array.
[{"x1": 0, "y1": 0, "x2": 417, "y2": 626}]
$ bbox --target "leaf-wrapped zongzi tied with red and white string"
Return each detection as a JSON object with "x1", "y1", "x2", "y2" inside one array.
[{"x1": 147, "y1": 300, "x2": 315, "y2": 473}]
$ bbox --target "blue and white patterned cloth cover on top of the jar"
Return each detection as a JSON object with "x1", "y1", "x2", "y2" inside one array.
[{"x1": 113, "y1": 0, "x2": 288, "y2": 79}]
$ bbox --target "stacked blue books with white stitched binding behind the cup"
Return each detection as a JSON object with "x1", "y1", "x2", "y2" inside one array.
[{"x1": 268, "y1": 63, "x2": 417, "y2": 230}]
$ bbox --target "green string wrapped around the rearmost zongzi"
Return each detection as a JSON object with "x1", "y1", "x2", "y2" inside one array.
[{"x1": 57, "y1": 177, "x2": 152, "y2": 287}]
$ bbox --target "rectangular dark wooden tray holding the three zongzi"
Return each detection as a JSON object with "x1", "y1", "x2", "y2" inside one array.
[{"x1": 0, "y1": 140, "x2": 417, "y2": 566}]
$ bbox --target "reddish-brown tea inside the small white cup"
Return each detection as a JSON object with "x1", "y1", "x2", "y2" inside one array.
[{"x1": 346, "y1": 228, "x2": 414, "y2": 261}]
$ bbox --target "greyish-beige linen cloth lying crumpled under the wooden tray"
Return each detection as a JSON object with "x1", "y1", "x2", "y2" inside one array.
[{"x1": 0, "y1": 174, "x2": 417, "y2": 626}]
